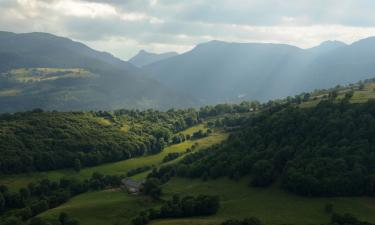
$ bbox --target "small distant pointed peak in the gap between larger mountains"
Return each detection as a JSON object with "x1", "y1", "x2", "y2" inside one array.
[{"x1": 129, "y1": 50, "x2": 178, "y2": 67}]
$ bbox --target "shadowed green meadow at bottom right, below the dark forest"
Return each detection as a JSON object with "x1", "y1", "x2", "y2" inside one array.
[{"x1": 151, "y1": 178, "x2": 375, "y2": 225}]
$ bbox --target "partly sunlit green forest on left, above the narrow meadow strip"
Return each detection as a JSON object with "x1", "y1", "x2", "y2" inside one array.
[{"x1": 0, "y1": 102, "x2": 258, "y2": 174}]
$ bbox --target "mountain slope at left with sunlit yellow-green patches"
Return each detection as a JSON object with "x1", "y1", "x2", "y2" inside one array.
[{"x1": 0, "y1": 32, "x2": 192, "y2": 112}]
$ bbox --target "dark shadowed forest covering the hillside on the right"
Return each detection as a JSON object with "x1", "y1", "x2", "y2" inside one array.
[{"x1": 150, "y1": 99, "x2": 375, "y2": 196}]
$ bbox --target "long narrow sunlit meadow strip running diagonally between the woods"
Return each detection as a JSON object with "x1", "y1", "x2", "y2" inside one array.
[{"x1": 0, "y1": 125, "x2": 227, "y2": 191}]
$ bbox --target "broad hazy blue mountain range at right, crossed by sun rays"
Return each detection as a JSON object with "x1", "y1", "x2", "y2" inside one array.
[{"x1": 143, "y1": 38, "x2": 375, "y2": 104}]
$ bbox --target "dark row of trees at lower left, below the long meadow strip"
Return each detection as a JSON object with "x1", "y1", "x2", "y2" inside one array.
[{"x1": 0, "y1": 173, "x2": 121, "y2": 221}]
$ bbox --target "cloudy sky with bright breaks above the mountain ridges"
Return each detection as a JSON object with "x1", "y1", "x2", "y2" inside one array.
[{"x1": 0, "y1": 0, "x2": 375, "y2": 60}]
